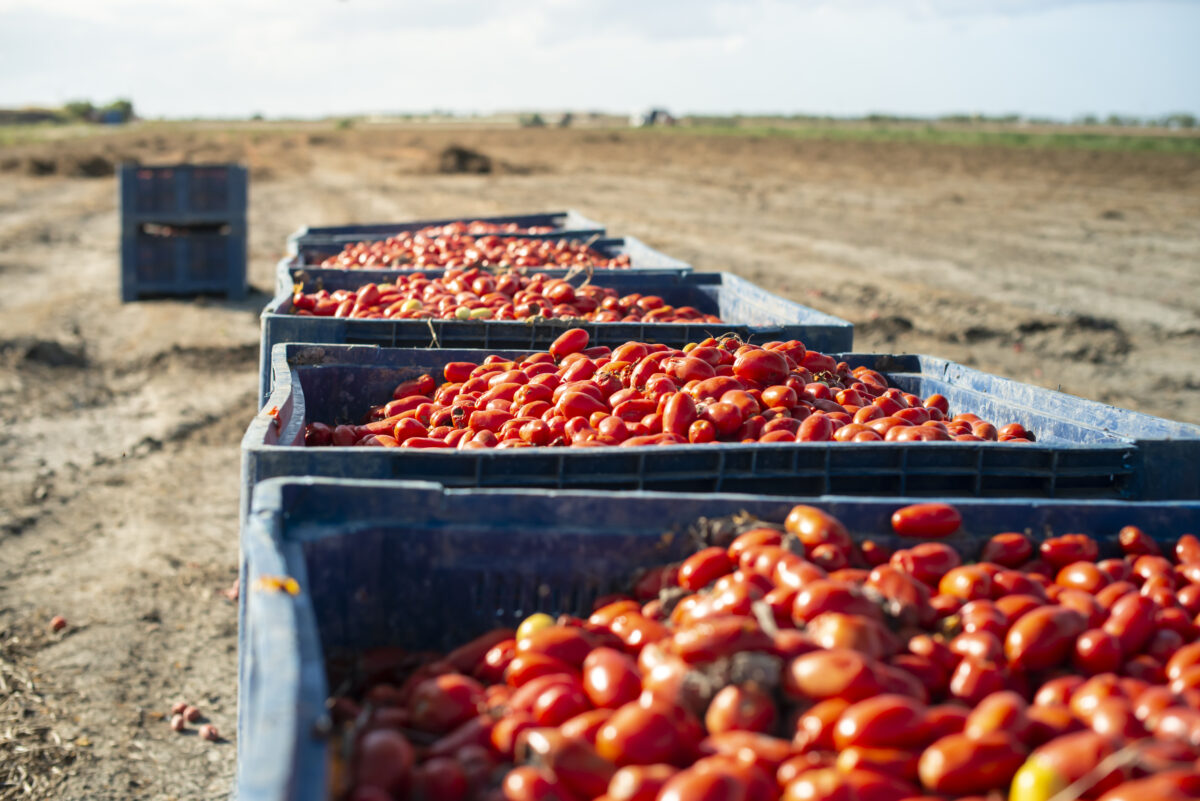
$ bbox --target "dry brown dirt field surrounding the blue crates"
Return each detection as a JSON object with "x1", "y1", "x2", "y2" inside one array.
[{"x1": 0, "y1": 127, "x2": 1200, "y2": 800}]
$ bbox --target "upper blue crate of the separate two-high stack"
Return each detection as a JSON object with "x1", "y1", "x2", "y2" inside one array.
[{"x1": 118, "y1": 164, "x2": 247, "y2": 225}]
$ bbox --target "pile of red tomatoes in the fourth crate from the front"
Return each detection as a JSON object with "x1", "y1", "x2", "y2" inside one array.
[{"x1": 320, "y1": 231, "x2": 630, "y2": 270}]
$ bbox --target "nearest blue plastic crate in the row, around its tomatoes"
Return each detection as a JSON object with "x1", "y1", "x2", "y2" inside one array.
[{"x1": 238, "y1": 480, "x2": 1200, "y2": 801}]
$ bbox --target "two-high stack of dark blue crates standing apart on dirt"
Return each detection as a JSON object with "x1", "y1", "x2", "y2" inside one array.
[{"x1": 118, "y1": 164, "x2": 247, "y2": 302}]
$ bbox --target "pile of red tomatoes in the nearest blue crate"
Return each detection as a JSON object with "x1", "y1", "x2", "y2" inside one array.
[{"x1": 330, "y1": 504, "x2": 1200, "y2": 801}]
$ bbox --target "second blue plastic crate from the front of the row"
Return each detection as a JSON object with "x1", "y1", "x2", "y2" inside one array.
[{"x1": 242, "y1": 344, "x2": 1200, "y2": 520}]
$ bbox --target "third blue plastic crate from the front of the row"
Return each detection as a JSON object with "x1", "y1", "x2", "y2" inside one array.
[{"x1": 259, "y1": 270, "x2": 854, "y2": 402}]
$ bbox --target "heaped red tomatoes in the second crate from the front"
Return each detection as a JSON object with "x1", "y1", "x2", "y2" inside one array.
[{"x1": 305, "y1": 329, "x2": 1033, "y2": 448}]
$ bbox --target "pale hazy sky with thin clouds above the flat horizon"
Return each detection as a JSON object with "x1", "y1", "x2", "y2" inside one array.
[{"x1": 0, "y1": 0, "x2": 1200, "y2": 118}]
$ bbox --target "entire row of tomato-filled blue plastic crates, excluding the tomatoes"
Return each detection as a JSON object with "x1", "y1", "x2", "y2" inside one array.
[{"x1": 229, "y1": 212, "x2": 1200, "y2": 801}]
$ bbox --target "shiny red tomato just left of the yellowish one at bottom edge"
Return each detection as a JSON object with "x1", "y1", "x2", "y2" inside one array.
[{"x1": 918, "y1": 731, "x2": 1026, "y2": 795}]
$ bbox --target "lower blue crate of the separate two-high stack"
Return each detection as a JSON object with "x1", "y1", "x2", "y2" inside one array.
[{"x1": 121, "y1": 223, "x2": 246, "y2": 301}]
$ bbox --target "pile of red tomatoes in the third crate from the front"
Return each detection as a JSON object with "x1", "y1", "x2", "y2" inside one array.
[{"x1": 292, "y1": 267, "x2": 721, "y2": 323}]
